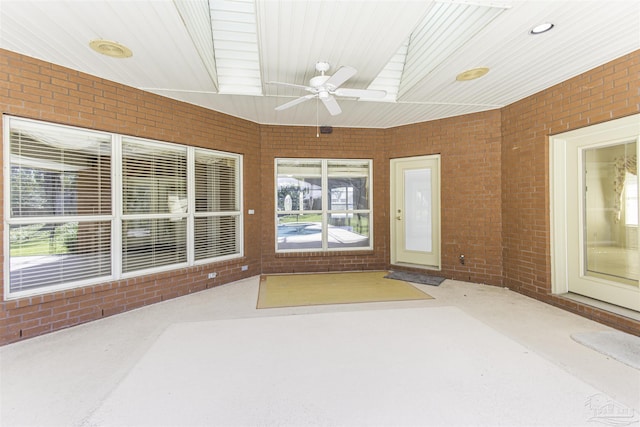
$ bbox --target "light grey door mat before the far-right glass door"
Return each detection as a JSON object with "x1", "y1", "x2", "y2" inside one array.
[{"x1": 571, "y1": 331, "x2": 640, "y2": 370}]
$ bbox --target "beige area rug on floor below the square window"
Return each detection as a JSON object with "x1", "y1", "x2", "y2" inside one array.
[{"x1": 257, "y1": 271, "x2": 433, "y2": 308}]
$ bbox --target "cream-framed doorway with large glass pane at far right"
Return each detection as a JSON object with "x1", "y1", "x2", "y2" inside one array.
[{"x1": 550, "y1": 115, "x2": 640, "y2": 311}]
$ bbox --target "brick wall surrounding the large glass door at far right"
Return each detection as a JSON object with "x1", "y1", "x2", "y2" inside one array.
[{"x1": 502, "y1": 51, "x2": 640, "y2": 335}]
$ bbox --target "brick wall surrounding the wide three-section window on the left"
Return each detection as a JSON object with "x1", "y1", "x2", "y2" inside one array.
[{"x1": 0, "y1": 49, "x2": 262, "y2": 345}]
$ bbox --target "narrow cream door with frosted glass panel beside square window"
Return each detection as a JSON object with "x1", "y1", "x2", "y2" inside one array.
[{"x1": 390, "y1": 155, "x2": 440, "y2": 270}]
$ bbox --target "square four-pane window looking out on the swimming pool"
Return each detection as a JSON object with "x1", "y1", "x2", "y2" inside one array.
[{"x1": 275, "y1": 159, "x2": 372, "y2": 252}]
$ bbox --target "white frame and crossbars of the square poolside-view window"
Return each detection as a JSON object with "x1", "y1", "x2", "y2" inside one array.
[{"x1": 274, "y1": 157, "x2": 374, "y2": 253}]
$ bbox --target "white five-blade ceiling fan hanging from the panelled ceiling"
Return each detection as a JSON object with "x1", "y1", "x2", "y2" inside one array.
[{"x1": 269, "y1": 62, "x2": 387, "y2": 116}]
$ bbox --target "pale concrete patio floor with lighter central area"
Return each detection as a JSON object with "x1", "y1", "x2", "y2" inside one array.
[{"x1": 0, "y1": 277, "x2": 640, "y2": 426}]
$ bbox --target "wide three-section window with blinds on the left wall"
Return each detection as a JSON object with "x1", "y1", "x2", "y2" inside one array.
[{"x1": 4, "y1": 117, "x2": 242, "y2": 298}]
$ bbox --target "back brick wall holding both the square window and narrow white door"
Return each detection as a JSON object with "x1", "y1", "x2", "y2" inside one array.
[{"x1": 261, "y1": 111, "x2": 502, "y2": 285}]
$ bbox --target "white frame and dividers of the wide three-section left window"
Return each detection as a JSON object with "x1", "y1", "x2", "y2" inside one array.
[{"x1": 3, "y1": 115, "x2": 244, "y2": 301}]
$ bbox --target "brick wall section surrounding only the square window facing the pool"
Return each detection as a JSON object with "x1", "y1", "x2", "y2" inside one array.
[{"x1": 260, "y1": 126, "x2": 389, "y2": 273}]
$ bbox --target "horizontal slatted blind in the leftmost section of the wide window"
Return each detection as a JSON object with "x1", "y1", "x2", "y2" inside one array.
[{"x1": 7, "y1": 119, "x2": 112, "y2": 292}]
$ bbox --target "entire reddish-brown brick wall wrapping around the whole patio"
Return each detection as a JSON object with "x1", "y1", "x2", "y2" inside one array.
[{"x1": 0, "y1": 46, "x2": 640, "y2": 345}]
